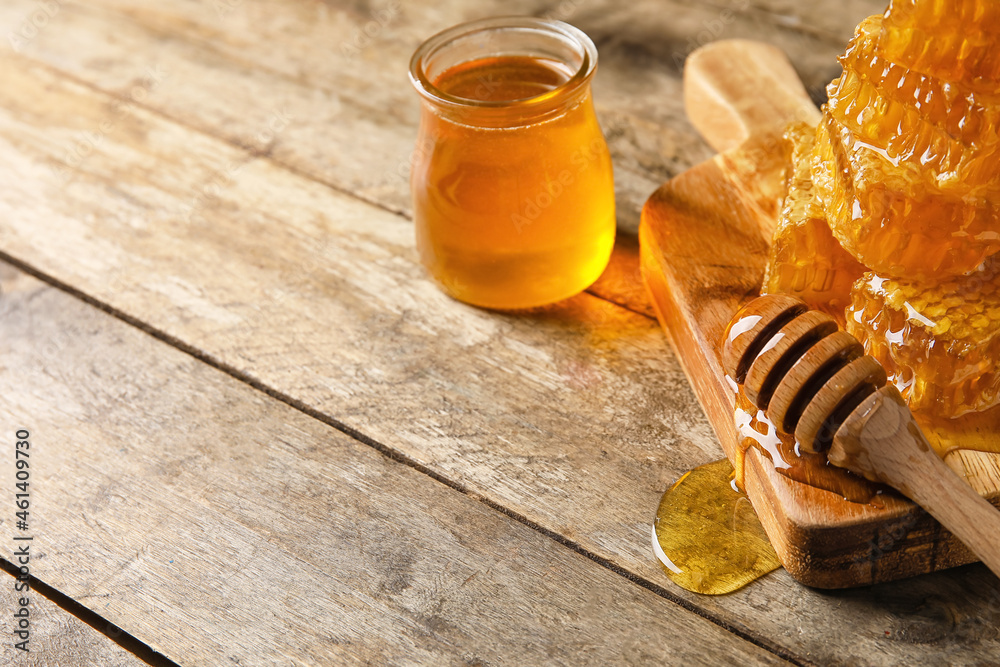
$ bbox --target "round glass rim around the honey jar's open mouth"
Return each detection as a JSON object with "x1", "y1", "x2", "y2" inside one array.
[{"x1": 410, "y1": 16, "x2": 597, "y2": 109}]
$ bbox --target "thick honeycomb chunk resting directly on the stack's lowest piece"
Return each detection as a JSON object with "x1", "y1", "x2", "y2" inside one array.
[{"x1": 813, "y1": 114, "x2": 1000, "y2": 282}]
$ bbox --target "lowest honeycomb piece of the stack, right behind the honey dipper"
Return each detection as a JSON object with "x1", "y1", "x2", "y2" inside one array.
[{"x1": 847, "y1": 255, "x2": 1000, "y2": 418}]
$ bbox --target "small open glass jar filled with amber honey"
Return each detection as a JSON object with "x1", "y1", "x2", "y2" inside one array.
[{"x1": 410, "y1": 18, "x2": 615, "y2": 309}]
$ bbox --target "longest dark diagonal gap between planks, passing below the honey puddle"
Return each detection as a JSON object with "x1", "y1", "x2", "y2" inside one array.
[{"x1": 0, "y1": 250, "x2": 804, "y2": 667}]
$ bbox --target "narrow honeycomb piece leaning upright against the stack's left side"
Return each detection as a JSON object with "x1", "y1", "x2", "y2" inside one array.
[{"x1": 761, "y1": 123, "x2": 865, "y2": 324}]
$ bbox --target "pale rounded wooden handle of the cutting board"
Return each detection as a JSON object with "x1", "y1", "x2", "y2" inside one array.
[{"x1": 684, "y1": 39, "x2": 820, "y2": 153}]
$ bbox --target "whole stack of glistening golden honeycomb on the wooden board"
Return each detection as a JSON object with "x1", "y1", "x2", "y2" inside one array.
[{"x1": 762, "y1": 0, "x2": 1000, "y2": 455}]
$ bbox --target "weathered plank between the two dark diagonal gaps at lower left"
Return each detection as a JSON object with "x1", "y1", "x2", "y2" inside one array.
[{"x1": 0, "y1": 265, "x2": 782, "y2": 665}]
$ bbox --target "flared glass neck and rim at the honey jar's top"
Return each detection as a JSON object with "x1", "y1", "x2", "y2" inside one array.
[{"x1": 410, "y1": 18, "x2": 597, "y2": 127}]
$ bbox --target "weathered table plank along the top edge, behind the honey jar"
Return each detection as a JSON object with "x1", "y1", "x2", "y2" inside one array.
[{"x1": 0, "y1": 0, "x2": 881, "y2": 312}]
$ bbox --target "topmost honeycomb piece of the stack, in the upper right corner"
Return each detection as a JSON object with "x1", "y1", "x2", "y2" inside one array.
[{"x1": 879, "y1": 0, "x2": 1000, "y2": 92}]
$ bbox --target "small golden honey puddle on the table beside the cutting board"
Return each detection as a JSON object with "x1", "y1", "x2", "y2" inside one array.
[{"x1": 653, "y1": 459, "x2": 781, "y2": 595}]
